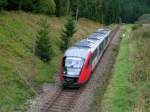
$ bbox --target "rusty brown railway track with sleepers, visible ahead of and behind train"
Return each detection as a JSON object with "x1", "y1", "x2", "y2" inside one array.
[{"x1": 40, "y1": 26, "x2": 120, "y2": 112}]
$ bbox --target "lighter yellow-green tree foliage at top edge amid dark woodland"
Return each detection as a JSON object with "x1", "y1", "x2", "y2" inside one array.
[{"x1": 34, "y1": 0, "x2": 56, "y2": 14}]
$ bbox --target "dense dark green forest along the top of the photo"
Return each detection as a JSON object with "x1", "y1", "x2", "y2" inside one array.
[{"x1": 0, "y1": 0, "x2": 150, "y2": 24}]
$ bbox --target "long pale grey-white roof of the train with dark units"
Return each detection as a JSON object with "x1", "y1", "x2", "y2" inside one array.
[{"x1": 65, "y1": 28, "x2": 111, "y2": 58}]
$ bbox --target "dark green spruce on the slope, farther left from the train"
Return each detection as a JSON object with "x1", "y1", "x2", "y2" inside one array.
[{"x1": 35, "y1": 22, "x2": 52, "y2": 62}]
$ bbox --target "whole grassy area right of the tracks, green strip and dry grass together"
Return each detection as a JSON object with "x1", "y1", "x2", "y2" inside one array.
[{"x1": 95, "y1": 24, "x2": 150, "y2": 112}]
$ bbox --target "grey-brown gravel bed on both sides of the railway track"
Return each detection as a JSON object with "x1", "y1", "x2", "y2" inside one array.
[{"x1": 27, "y1": 27, "x2": 121, "y2": 112}]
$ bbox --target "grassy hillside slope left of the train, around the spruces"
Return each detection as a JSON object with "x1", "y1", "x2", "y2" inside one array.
[{"x1": 0, "y1": 11, "x2": 100, "y2": 112}]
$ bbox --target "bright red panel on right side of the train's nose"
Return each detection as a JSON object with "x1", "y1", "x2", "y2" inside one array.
[{"x1": 78, "y1": 52, "x2": 92, "y2": 84}]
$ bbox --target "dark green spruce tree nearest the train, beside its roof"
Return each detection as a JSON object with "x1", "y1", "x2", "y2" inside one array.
[{"x1": 59, "y1": 17, "x2": 76, "y2": 52}]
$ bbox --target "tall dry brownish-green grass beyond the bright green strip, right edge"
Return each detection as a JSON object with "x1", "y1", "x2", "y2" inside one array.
[{"x1": 129, "y1": 25, "x2": 150, "y2": 112}]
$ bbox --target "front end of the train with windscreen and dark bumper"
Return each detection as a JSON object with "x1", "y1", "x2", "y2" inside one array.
[{"x1": 60, "y1": 48, "x2": 88, "y2": 87}]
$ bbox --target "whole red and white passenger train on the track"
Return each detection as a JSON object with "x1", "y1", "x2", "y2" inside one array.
[{"x1": 60, "y1": 28, "x2": 111, "y2": 87}]
